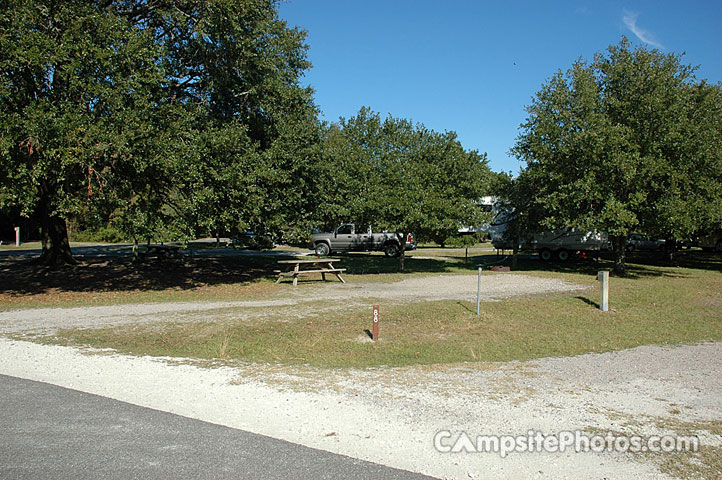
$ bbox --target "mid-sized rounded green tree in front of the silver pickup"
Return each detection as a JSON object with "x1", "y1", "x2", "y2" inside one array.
[{"x1": 319, "y1": 108, "x2": 491, "y2": 269}]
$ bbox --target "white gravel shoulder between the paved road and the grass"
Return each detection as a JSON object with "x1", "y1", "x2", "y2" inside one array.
[{"x1": 0, "y1": 338, "x2": 722, "y2": 479}]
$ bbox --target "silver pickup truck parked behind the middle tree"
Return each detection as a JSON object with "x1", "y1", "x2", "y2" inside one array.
[{"x1": 311, "y1": 223, "x2": 416, "y2": 257}]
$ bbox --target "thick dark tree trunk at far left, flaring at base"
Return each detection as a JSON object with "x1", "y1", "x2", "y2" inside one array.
[{"x1": 38, "y1": 184, "x2": 78, "y2": 267}]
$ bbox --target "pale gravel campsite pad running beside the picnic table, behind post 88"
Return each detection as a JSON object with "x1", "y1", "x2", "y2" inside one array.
[{"x1": 0, "y1": 273, "x2": 588, "y2": 333}]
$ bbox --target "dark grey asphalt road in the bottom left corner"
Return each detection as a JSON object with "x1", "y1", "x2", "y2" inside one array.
[{"x1": 0, "y1": 375, "x2": 430, "y2": 480}]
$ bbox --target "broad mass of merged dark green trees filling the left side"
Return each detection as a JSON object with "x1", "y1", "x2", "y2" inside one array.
[{"x1": 0, "y1": 0, "x2": 319, "y2": 263}]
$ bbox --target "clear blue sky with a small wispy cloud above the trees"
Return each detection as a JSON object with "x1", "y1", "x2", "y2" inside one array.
[{"x1": 279, "y1": 0, "x2": 722, "y2": 173}]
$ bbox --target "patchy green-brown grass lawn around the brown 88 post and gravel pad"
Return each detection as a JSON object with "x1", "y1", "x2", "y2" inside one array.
[{"x1": 22, "y1": 249, "x2": 722, "y2": 367}]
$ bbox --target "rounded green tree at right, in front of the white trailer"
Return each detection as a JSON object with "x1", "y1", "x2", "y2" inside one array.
[{"x1": 512, "y1": 38, "x2": 722, "y2": 273}]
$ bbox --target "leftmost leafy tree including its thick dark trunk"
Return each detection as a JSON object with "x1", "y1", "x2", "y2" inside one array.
[{"x1": 0, "y1": 1, "x2": 183, "y2": 263}]
